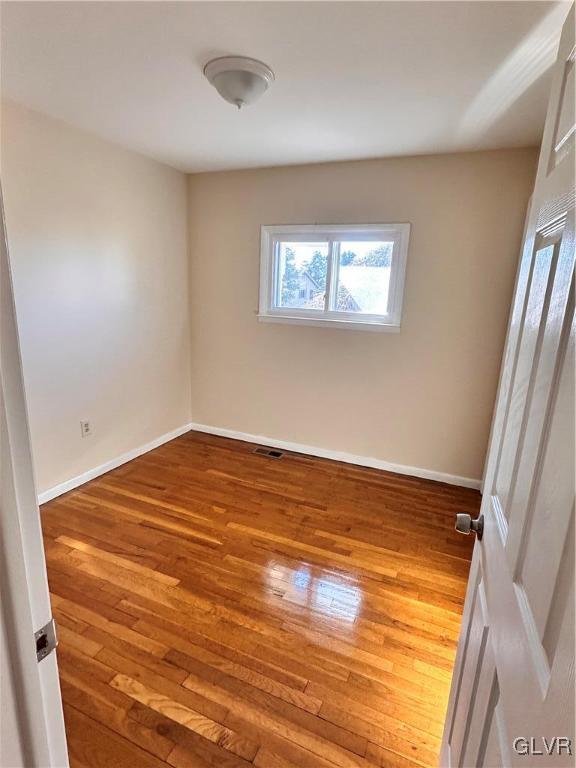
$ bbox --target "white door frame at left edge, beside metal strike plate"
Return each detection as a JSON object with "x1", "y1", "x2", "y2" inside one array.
[{"x1": 0, "y1": 183, "x2": 68, "y2": 768}]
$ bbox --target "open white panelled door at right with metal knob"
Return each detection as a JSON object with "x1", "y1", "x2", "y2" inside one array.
[{"x1": 441, "y1": 7, "x2": 575, "y2": 768}]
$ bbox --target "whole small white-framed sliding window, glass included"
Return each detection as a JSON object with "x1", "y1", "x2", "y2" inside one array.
[{"x1": 258, "y1": 224, "x2": 410, "y2": 331}]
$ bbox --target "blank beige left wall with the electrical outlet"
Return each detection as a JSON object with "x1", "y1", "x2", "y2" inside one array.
[{"x1": 1, "y1": 104, "x2": 190, "y2": 492}]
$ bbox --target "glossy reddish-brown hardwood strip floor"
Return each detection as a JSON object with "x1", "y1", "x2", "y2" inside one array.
[{"x1": 42, "y1": 432, "x2": 480, "y2": 768}]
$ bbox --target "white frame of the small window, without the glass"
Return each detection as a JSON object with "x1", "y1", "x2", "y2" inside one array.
[{"x1": 258, "y1": 224, "x2": 410, "y2": 333}]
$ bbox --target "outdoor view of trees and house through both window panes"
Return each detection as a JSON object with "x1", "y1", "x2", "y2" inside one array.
[{"x1": 275, "y1": 240, "x2": 394, "y2": 314}]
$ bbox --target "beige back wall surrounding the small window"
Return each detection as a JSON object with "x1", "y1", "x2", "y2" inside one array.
[{"x1": 189, "y1": 149, "x2": 537, "y2": 478}]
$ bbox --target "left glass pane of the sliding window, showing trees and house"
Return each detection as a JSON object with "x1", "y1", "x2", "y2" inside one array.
[{"x1": 274, "y1": 242, "x2": 328, "y2": 311}]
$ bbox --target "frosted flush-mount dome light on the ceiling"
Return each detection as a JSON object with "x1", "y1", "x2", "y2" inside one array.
[{"x1": 204, "y1": 56, "x2": 274, "y2": 109}]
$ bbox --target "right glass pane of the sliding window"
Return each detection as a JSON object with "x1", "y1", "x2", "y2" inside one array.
[{"x1": 334, "y1": 240, "x2": 394, "y2": 315}]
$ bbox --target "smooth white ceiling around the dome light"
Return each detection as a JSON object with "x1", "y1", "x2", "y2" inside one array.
[{"x1": 2, "y1": 1, "x2": 569, "y2": 172}]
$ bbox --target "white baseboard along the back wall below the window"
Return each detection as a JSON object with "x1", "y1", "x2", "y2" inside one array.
[{"x1": 190, "y1": 423, "x2": 480, "y2": 489}]
